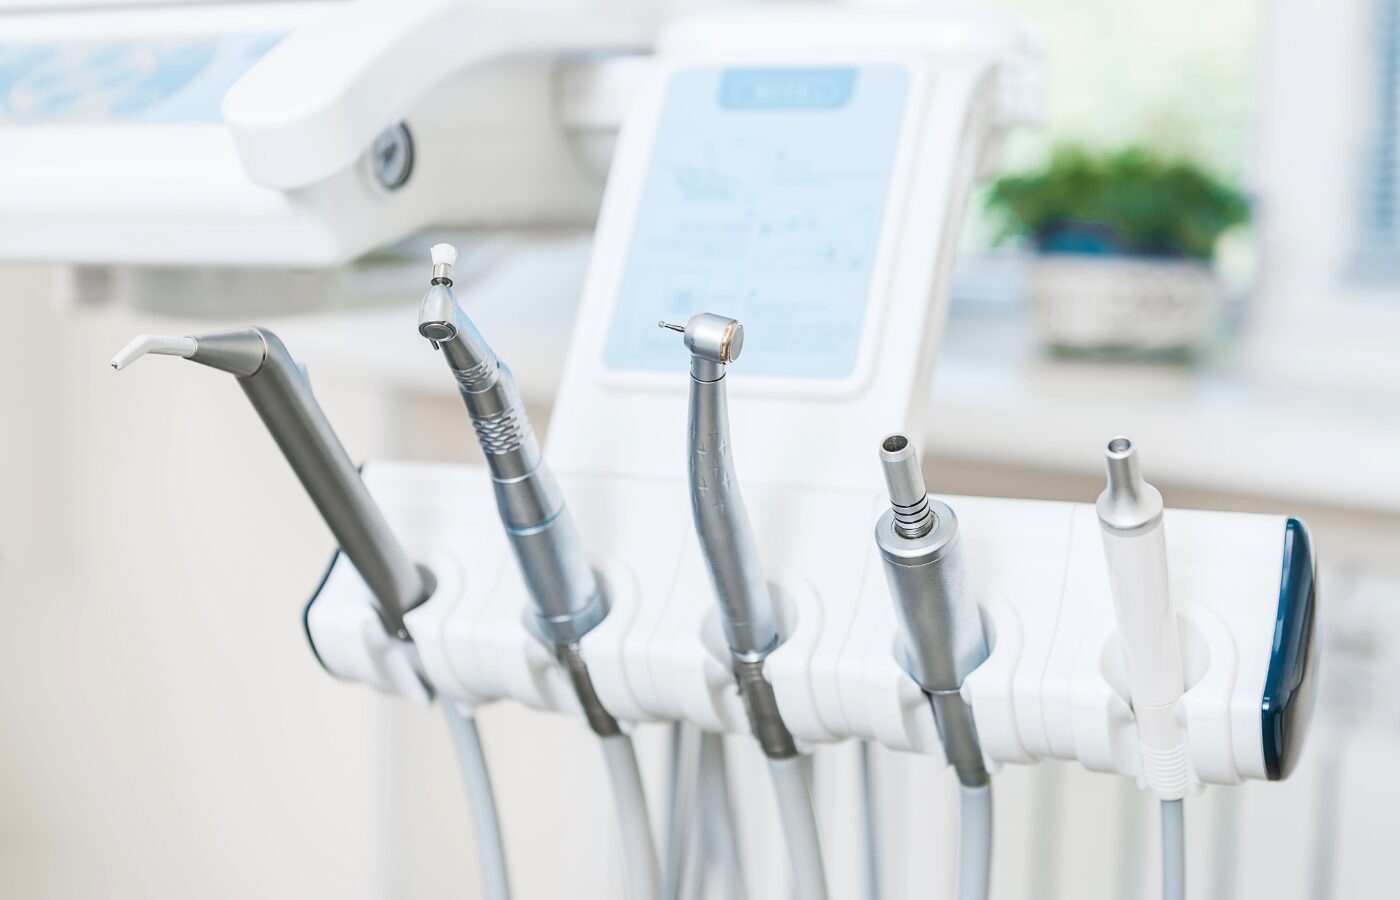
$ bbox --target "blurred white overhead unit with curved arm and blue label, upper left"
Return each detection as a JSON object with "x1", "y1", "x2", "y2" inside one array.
[{"x1": 0, "y1": 0, "x2": 654, "y2": 269}]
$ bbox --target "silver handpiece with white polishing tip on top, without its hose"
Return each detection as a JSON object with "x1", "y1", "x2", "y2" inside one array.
[{"x1": 419, "y1": 244, "x2": 608, "y2": 655}]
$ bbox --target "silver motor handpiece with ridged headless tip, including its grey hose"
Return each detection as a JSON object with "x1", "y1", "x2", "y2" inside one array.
[{"x1": 875, "y1": 434, "x2": 991, "y2": 900}]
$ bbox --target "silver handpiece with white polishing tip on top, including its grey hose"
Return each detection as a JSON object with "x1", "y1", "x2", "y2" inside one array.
[{"x1": 419, "y1": 244, "x2": 661, "y2": 900}]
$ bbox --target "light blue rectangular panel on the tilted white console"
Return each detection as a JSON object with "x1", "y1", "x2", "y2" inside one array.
[{"x1": 603, "y1": 66, "x2": 909, "y2": 378}]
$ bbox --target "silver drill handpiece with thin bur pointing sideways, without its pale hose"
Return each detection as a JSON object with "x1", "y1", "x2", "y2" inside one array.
[{"x1": 658, "y1": 312, "x2": 797, "y2": 759}]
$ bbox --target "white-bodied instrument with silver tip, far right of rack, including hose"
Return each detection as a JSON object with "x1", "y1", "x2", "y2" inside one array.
[{"x1": 1096, "y1": 437, "x2": 1189, "y2": 900}]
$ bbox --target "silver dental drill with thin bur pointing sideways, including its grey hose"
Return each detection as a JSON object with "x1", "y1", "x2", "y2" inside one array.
[{"x1": 658, "y1": 312, "x2": 826, "y2": 900}]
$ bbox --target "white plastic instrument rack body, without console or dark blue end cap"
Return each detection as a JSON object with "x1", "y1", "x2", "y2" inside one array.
[{"x1": 308, "y1": 463, "x2": 1287, "y2": 789}]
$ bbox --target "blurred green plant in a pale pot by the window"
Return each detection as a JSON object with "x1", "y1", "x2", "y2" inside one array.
[{"x1": 987, "y1": 146, "x2": 1249, "y2": 356}]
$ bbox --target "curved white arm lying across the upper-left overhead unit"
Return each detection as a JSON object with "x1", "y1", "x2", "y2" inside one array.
[{"x1": 223, "y1": 0, "x2": 651, "y2": 190}]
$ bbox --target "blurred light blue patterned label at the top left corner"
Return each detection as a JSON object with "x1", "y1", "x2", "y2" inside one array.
[{"x1": 0, "y1": 34, "x2": 283, "y2": 125}]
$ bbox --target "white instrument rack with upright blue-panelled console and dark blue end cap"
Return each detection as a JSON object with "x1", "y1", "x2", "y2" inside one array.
[{"x1": 301, "y1": 0, "x2": 1316, "y2": 867}]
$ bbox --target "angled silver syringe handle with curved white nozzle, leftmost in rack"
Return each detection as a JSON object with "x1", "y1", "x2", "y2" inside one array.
[{"x1": 112, "y1": 328, "x2": 435, "y2": 640}]
